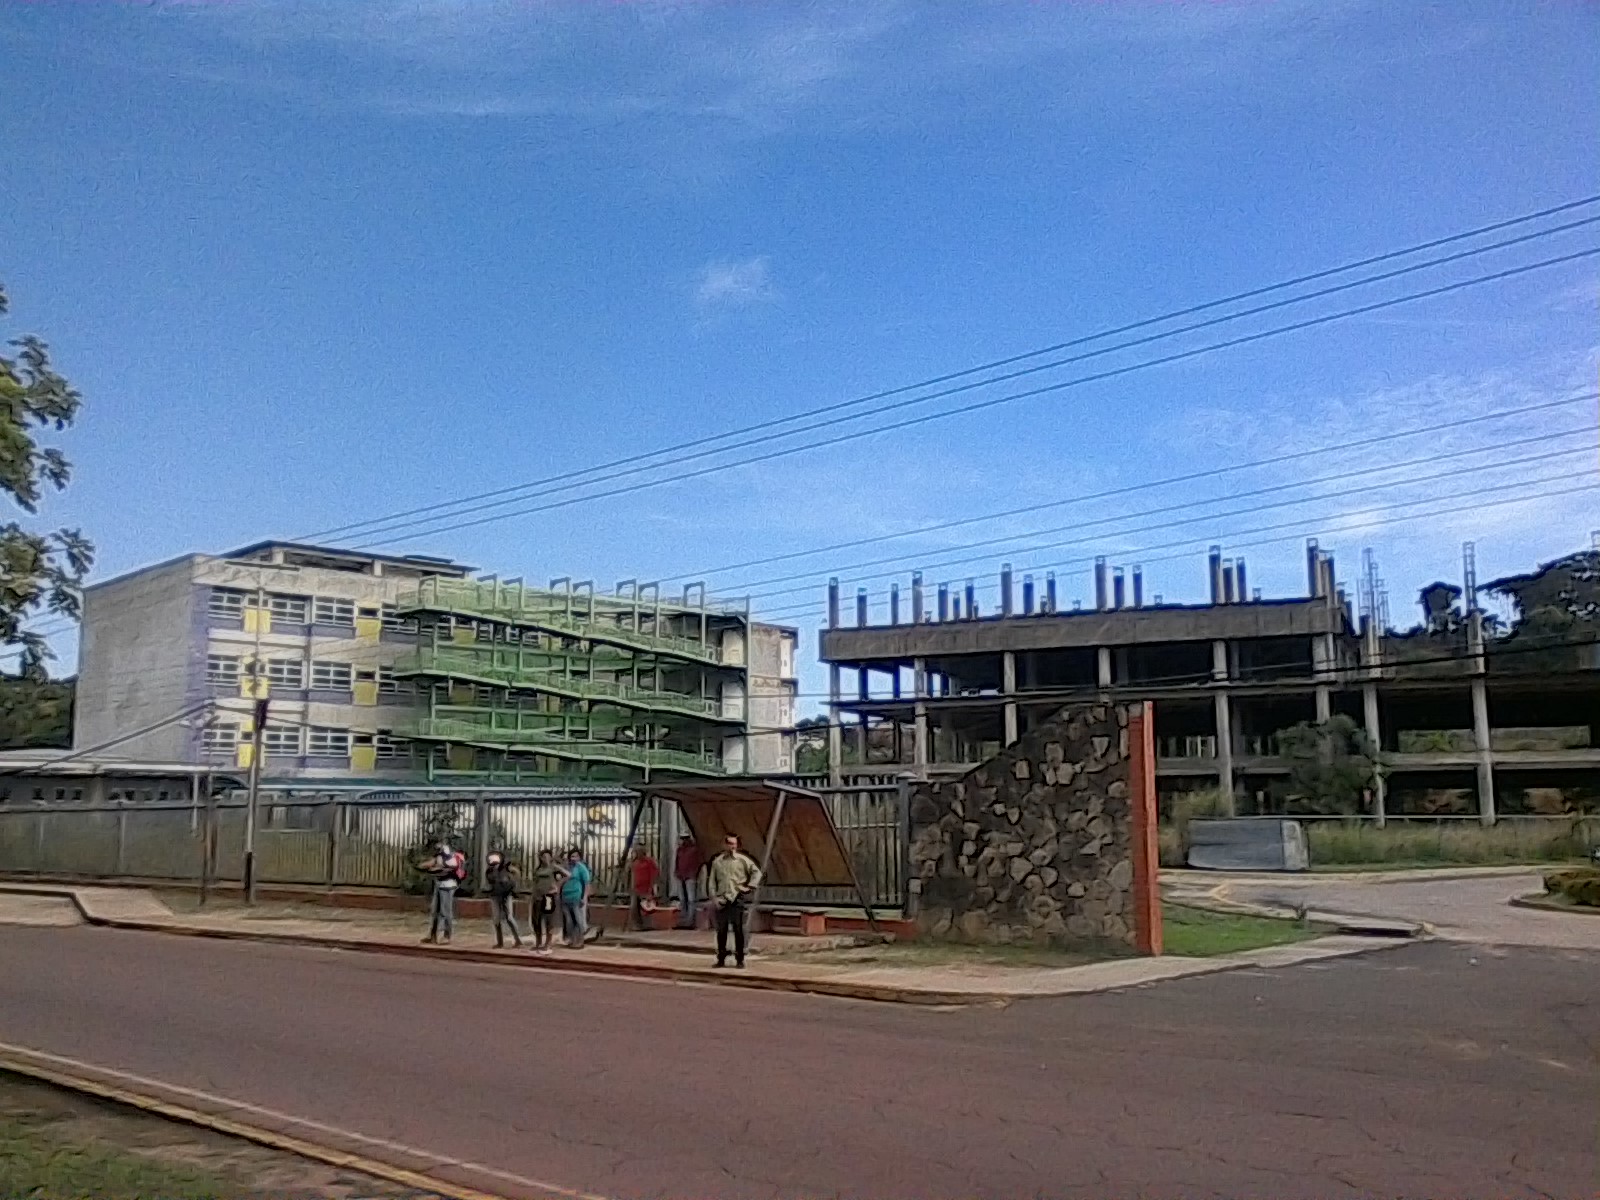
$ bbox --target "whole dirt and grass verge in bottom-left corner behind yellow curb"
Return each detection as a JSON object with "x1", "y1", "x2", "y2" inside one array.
[{"x1": 0, "y1": 1072, "x2": 438, "y2": 1200}]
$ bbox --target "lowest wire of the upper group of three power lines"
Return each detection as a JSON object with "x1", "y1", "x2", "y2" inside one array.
[{"x1": 358, "y1": 246, "x2": 1600, "y2": 550}]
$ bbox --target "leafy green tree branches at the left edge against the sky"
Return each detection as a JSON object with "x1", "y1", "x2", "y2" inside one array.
[{"x1": 0, "y1": 276, "x2": 94, "y2": 680}]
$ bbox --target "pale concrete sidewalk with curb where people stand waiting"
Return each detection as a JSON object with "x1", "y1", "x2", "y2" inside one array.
[{"x1": 0, "y1": 883, "x2": 1394, "y2": 1005}]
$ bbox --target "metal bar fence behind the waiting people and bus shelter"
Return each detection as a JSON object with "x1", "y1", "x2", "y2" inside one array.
[{"x1": 0, "y1": 779, "x2": 906, "y2": 907}]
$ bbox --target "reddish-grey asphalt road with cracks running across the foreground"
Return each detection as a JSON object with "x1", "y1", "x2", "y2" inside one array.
[{"x1": 0, "y1": 928, "x2": 1600, "y2": 1198}]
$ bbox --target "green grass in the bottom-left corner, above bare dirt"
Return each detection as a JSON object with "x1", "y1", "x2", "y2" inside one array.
[{"x1": 0, "y1": 1115, "x2": 229, "y2": 1200}]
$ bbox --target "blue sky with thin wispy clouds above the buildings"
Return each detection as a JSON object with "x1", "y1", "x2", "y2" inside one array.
[{"x1": 0, "y1": 0, "x2": 1600, "y2": 704}]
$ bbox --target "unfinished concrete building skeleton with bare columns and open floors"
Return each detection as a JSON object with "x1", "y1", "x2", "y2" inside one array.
[{"x1": 821, "y1": 542, "x2": 1600, "y2": 821}]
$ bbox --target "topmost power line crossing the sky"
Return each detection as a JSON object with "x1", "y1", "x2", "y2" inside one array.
[{"x1": 304, "y1": 194, "x2": 1600, "y2": 541}]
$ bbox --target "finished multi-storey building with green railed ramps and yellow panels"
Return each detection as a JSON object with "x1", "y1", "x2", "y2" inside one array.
[{"x1": 74, "y1": 541, "x2": 797, "y2": 782}]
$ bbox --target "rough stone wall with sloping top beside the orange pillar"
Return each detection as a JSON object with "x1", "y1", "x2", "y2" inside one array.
[{"x1": 910, "y1": 704, "x2": 1138, "y2": 949}]
